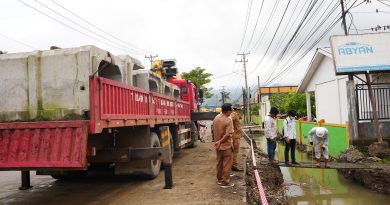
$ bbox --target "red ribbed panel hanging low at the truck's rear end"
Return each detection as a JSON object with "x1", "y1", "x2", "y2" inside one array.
[{"x1": 0, "y1": 121, "x2": 88, "y2": 170}]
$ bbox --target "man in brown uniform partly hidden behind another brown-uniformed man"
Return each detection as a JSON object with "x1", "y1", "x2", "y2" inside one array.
[{"x1": 230, "y1": 104, "x2": 242, "y2": 172}]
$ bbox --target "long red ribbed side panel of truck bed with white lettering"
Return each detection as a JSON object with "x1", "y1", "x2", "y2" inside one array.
[{"x1": 90, "y1": 76, "x2": 190, "y2": 133}]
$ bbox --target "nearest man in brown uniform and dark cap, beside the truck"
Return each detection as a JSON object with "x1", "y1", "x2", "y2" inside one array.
[{"x1": 213, "y1": 103, "x2": 234, "y2": 188}]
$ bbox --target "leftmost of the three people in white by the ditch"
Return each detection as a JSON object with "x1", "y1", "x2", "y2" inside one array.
[{"x1": 264, "y1": 107, "x2": 279, "y2": 163}]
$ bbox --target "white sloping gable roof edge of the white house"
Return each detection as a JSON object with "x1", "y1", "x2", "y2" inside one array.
[{"x1": 297, "y1": 47, "x2": 333, "y2": 92}]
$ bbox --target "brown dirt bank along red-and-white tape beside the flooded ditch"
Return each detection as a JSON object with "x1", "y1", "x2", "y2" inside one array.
[{"x1": 246, "y1": 149, "x2": 288, "y2": 205}]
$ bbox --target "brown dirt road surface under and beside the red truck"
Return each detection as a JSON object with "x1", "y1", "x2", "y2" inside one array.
[{"x1": 0, "y1": 139, "x2": 248, "y2": 205}]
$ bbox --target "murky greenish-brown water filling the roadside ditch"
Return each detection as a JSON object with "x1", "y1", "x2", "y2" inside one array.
[{"x1": 254, "y1": 135, "x2": 390, "y2": 205}]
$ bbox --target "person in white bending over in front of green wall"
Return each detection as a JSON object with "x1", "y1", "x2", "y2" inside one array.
[{"x1": 309, "y1": 127, "x2": 329, "y2": 168}]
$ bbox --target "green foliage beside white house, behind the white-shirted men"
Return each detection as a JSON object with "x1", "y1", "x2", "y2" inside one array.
[{"x1": 270, "y1": 93, "x2": 315, "y2": 116}]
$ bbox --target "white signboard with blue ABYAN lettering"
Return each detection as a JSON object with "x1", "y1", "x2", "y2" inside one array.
[{"x1": 330, "y1": 33, "x2": 390, "y2": 75}]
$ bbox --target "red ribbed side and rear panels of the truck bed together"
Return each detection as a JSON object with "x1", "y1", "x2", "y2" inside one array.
[{"x1": 0, "y1": 77, "x2": 190, "y2": 170}]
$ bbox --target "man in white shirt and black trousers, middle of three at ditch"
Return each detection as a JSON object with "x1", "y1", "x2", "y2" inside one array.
[{"x1": 283, "y1": 110, "x2": 299, "y2": 165}]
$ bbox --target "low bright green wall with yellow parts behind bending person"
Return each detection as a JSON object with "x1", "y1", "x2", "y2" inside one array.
[{"x1": 277, "y1": 119, "x2": 349, "y2": 157}]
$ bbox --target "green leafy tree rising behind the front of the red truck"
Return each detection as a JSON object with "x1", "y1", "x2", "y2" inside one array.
[{"x1": 182, "y1": 67, "x2": 213, "y2": 98}]
